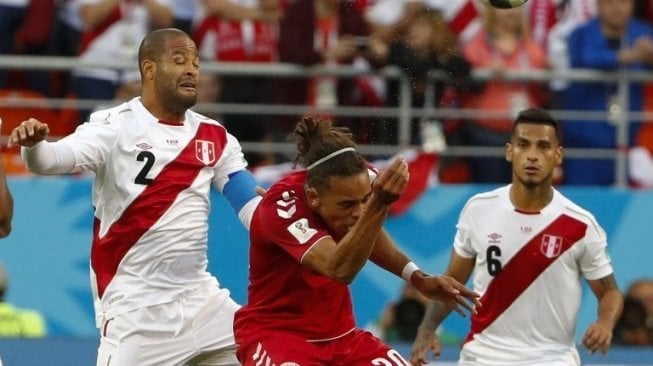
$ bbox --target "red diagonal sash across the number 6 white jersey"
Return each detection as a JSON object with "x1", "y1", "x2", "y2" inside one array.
[{"x1": 464, "y1": 215, "x2": 587, "y2": 343}]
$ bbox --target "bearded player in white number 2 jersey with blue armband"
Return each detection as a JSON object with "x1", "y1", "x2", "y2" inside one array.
[{"x1": 9, "y1": 28, "x2": 260, "y2": 366}]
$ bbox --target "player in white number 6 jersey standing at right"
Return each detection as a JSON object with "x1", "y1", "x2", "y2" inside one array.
[{"x1": 411, "y1": 109, "x2": 623, "y2": 366}]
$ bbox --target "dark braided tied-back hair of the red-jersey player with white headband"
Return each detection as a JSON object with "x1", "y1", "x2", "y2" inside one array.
[{"x1": 288, "y1": 117, "x2": 367, "y2": 192}]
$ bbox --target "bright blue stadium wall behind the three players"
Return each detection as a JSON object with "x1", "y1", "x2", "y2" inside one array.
[{"x1": 0, "y1": 177, "x2": 653, "y2": 344}]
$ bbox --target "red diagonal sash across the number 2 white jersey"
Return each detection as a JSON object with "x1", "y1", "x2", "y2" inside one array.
[{"x1": 91, "y1": 123, "x2": 227, "y2": 298}]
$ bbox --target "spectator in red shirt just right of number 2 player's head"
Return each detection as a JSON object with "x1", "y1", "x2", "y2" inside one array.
[{"x1": 193, "y1": 0, "x2": 282, "y2": 166}]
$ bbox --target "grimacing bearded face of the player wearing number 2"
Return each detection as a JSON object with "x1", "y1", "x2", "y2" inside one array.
[{"x1": 155, "y1": 36, "x2": 199, "y2": 112}]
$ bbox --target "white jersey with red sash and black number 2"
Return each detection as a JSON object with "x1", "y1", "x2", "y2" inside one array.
[{"x1": 59, "y1": 98, "x2": 246, "y2": 320}]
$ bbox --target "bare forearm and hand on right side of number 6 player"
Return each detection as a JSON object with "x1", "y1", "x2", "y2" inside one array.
[{"x1": 583, "y1": 274, "x2": 624, "y2": 354}]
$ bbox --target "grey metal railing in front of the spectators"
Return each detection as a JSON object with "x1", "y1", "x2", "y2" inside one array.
[{"x1": 0, "y1": 55, "x2": 653, "y2": 187}]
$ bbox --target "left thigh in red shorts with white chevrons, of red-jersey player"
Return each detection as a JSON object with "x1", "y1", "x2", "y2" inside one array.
[{"x1": 237, "y1": 332, "x2": 329, "y2": 366}]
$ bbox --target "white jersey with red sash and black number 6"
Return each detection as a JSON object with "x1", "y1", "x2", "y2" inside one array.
[{"x1": 454, "y1": 186, "x2": 612, "y2": 366}]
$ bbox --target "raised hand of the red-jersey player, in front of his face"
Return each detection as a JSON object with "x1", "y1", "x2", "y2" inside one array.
[{"x1": 370, "y1": 156, "x2": 409, "y2": 206}]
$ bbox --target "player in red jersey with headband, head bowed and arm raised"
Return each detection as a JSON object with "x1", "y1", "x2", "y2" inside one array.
[{"x1": 234, "y1": 118, "x2": 480, "y2": 366}]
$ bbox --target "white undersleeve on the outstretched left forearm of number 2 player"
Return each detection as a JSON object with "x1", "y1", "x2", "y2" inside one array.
[{"x1": 21, "y1": 141, "x2": 75, "y2": 174}]
